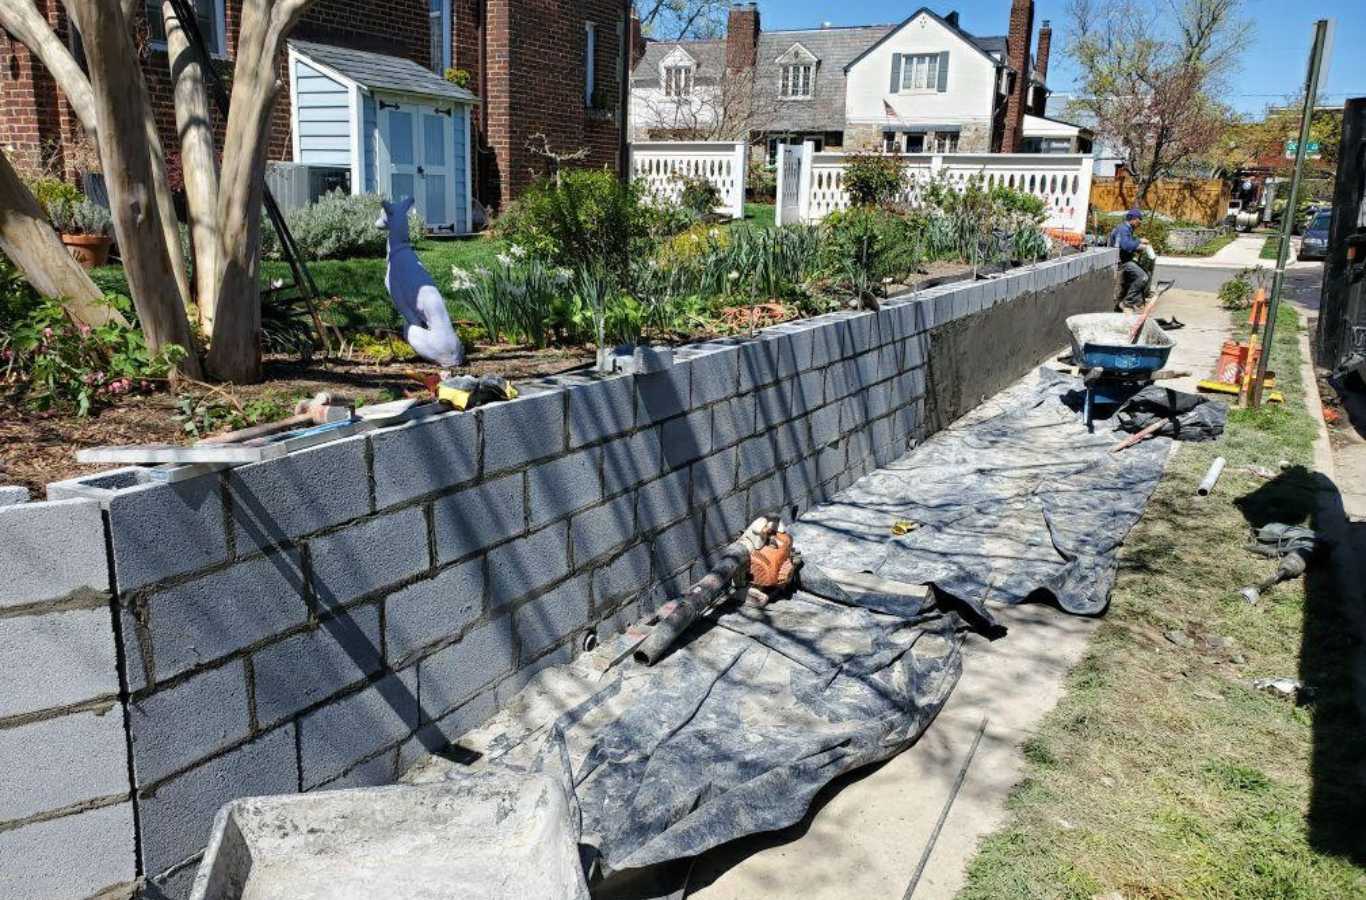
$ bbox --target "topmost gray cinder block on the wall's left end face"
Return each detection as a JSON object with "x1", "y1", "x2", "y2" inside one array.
[{"x1": 0, "y1": 497, "x2": 109, "y2": 608}]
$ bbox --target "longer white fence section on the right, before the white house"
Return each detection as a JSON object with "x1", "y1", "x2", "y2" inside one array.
[{"x1": 777, "y1": 143, "x2": 1093, "y2": 234}]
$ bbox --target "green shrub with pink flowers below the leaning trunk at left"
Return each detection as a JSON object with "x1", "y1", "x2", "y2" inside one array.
[{"x1": 0, "y1": 296, "x2": 186, "y2": 415}]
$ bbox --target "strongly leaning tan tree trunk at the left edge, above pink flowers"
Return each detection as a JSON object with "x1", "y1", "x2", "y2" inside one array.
[{"x1": 0, "y1": 150, "x2": 127, "y2": 328}]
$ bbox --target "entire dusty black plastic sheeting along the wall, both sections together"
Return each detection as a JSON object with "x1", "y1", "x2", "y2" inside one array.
[{"x1": 412, "y1": 370, "x2": 1172, "y2": 874}]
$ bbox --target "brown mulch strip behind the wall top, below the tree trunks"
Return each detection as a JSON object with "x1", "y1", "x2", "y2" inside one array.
[{"x1": 0, "y1": 347, "x2": 593, "y2": 500}]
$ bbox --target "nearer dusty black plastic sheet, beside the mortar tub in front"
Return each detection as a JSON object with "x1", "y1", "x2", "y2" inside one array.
[{"x1": 489, "y1": 591, "x2": 966, "y2": 873}]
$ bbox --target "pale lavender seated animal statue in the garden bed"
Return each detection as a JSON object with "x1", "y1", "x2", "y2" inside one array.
[{"x1": 374, "y1": 197, "x2": 464, "y2": 366}]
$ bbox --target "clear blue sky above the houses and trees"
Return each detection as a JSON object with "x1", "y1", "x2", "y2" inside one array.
[{"x1": 759, "y1": 0, "x2": 1366, "y2": 113}]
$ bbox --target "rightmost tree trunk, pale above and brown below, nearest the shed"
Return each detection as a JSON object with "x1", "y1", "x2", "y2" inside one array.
[{"x1": 209, "y1": 0, "x2": 311, "y2": 384}]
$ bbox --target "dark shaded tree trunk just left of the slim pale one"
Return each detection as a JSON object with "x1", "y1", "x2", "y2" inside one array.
[{"x1": 67, "y1": 0, "x2": 201, "y2": 377}]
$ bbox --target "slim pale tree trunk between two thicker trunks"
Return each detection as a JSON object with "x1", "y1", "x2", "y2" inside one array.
[{"x1": 161, "y1": 1, "x2": 219, "y2": 335}]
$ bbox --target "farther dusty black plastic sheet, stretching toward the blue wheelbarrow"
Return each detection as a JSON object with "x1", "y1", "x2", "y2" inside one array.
[{"x1": 792, "y1": 369, "x2": 1172, "y2": 616}]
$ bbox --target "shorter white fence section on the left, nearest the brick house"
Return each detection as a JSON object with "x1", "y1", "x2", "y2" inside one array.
[{"x1": 630, "y1": 141, "x2": 750, "y2": 219}]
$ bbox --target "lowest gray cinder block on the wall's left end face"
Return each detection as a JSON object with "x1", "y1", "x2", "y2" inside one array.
[{"x1": 0, "y1": 802, "x2": 137, "y2": 900}]
